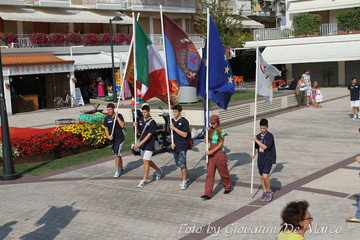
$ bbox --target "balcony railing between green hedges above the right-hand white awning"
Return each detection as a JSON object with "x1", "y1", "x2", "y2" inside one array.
[{"x1": 253, "y1": 23, "x2": 344, "y2": 41}]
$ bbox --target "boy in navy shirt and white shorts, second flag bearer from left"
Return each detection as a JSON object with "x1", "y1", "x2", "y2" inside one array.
[{"x1": 134, "y1": 105, "x2": 163, "y2": 187}]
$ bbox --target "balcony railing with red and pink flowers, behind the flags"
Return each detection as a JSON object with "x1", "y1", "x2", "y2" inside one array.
[{"x1": 12, "y1": 34, "x2": 204, "y2": 48}]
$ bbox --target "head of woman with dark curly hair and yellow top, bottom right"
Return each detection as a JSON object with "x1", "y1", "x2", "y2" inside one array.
[{"x1": 278, "y1": 201, "x2": 313, "y2": 240}]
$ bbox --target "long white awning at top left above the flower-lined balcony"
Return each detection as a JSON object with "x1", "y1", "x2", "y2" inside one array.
[{"x1": 0, "y1": 6, "x2": 132, "y2": 25}]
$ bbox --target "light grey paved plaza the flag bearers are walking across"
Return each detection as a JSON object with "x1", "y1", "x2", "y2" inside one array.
[{"x1": 0, "y1": 88, "x2": 360, "y2": 240}]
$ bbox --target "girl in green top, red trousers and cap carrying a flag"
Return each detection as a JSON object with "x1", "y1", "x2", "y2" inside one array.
[{"x1": 201, "y1": 115, "x2": 231, "y2": 200}]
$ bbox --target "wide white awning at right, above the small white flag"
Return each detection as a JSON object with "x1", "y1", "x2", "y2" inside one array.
[{"x1": 262, "y1": 41, "x2": 360, "y2": 64}]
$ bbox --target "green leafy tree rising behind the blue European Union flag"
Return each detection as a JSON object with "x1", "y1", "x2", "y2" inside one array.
[{"x1": 195, "y1": 0, "x2": 252, "y2": 47}]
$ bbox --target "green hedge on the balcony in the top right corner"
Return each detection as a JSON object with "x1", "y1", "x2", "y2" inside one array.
[{"x1": 336, "y1": 9, "x2": 360, "y2": 31}]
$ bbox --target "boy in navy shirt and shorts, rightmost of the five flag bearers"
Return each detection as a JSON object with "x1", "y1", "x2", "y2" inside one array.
[{"x1": 252, "y1": 118, "x2": 276, "y2": 201}]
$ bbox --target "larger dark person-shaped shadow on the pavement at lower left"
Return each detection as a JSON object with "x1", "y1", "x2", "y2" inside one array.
[{"x1": 20, "y1": 203, "x2": 80, "y2": 240}]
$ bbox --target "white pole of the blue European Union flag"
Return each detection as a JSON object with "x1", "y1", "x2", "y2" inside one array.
[{"x1": 205, "y1": 8, "x2": 210, "y2": 163}]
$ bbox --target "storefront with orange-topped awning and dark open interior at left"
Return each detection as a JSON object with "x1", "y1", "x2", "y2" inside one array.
[{"x1": 2, "y1": 55, "x2": 75, "y2": 114}]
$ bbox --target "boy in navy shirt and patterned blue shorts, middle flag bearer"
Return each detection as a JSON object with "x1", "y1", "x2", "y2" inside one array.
[{"x1": 170, "y1": 105, "x2": 190, "y2": 190}]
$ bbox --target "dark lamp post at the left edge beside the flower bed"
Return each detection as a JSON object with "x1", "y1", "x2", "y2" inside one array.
[{"x1": 0, "y1": 40, "x2": 21, "y2": 180}]
